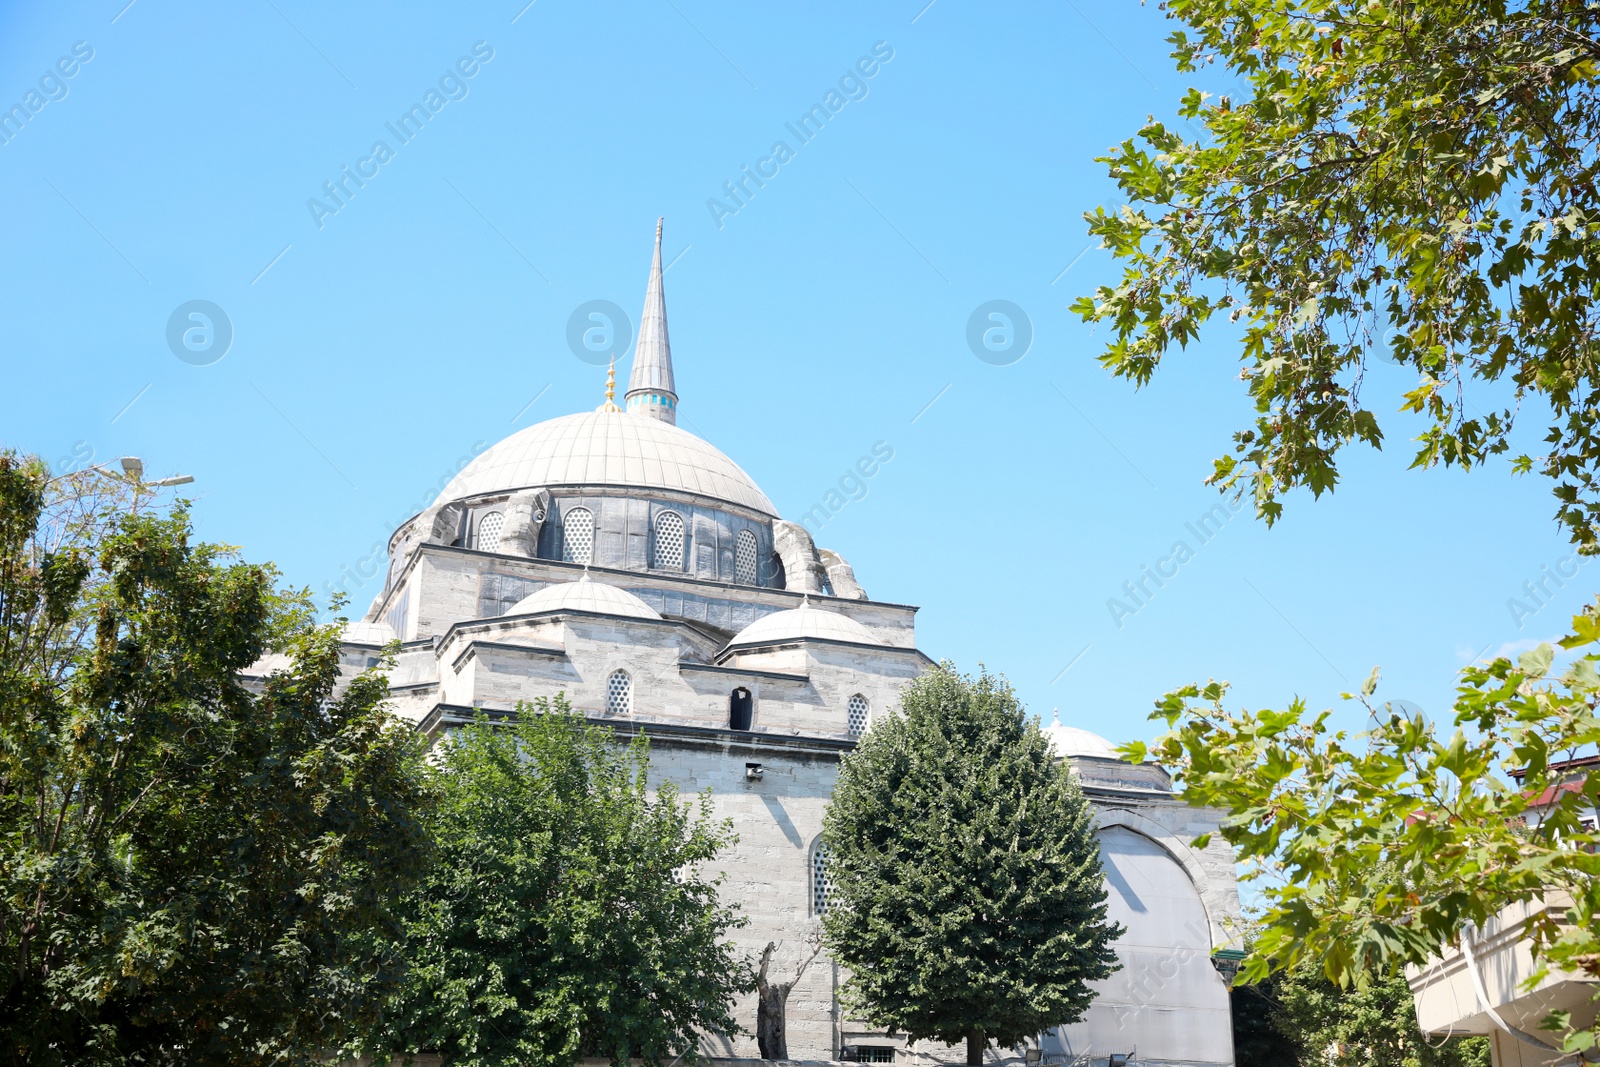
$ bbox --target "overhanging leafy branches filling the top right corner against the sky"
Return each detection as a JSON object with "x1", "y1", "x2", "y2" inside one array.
[{"x1": 1074, "y1": 0, "x2": 1600, "y2": 550}]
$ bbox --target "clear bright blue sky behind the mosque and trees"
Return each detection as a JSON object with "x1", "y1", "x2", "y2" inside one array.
[{"x1": 0, "y1": 0, "x2": 1592, "y2": 751}]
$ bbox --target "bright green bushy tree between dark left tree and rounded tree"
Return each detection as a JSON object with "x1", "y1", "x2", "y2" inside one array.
[{"x1": 365, "y1": 696, "x2": 755, "y2": 1067}]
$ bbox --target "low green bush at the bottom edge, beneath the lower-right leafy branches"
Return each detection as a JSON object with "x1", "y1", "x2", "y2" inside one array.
[{"x1": 1267, "y1": 965, "x2": 1490, "y2": 1067}]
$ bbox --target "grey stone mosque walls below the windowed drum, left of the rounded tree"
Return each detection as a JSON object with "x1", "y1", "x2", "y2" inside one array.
[{"x1": 346, "y1": 524, "x2": 930, "y2": 1061}]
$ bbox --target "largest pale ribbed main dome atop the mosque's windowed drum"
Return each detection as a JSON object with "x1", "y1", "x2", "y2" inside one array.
[{"x1": 437, "y1": 410, "x2": 778, "y2": 518}]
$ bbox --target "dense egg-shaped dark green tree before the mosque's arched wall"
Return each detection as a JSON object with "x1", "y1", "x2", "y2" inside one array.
[{"x1": 822, "y1": 664, "x2": 1123, "y2": 1064}]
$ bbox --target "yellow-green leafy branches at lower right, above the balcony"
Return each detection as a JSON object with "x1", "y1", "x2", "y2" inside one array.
[{"x1": 1125, "y1": 608, "x2": 1600, "y2": 1049}]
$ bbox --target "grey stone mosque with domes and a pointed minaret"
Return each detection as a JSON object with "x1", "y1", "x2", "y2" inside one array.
[{"x1": 346, "y1": 224, "x2": 1238, "y2": 1067}]
